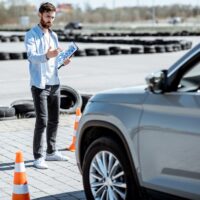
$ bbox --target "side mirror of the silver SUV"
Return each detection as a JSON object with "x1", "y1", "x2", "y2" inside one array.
[{"x1": 146, "y1": 70, "x2": 167, "y2": 94}]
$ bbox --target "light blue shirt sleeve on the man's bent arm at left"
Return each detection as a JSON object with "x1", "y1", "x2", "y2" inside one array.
[{"x1": 25, "y1": 31, "x2": 48, "y2": 64}]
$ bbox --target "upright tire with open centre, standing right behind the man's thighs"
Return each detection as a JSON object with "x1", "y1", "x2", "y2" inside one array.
[{"x1": 60, "y1": 85, "x2": 82, "y2": 114}]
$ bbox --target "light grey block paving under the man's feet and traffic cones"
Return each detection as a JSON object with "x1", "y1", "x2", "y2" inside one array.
[{"x1": 0, "y1": 115, "x2": 86, "y2": 200}]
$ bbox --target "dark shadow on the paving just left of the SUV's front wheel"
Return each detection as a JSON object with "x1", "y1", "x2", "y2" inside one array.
[{"x1": 33, "y1": 190, "x2": 86, "y2": 200}]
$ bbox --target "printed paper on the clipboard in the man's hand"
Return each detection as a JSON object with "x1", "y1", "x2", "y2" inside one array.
[{"x1": 56, "y1": 42, "x2": 78, "y2": 68}]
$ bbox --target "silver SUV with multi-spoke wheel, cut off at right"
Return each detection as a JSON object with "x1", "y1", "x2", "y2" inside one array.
[{"x1": 76, "y1": 45, "x2": 200, "y2": 200}]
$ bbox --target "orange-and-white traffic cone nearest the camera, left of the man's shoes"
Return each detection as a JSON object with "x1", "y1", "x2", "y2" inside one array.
[{"x1": 12, "y1": 151, "x2": 30, "y2": 200}]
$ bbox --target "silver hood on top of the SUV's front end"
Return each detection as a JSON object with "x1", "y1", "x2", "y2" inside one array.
[{"x1": 90, "y1": 85, "x2": 148, "y2": 104}]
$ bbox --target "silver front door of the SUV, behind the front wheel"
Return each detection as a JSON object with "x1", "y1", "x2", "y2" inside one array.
[{"x1": 138, "y1": 64, "x2": 200, "y2": 199}]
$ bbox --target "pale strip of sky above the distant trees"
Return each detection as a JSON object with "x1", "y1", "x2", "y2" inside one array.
[{"x1": 28, "y1": 0, "x2": 200, "y2": 8}]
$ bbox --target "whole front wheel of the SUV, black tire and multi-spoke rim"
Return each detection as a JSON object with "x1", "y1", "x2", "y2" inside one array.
[{"x1": 83, "y1": 137, "x2": 140, "y2": 200}]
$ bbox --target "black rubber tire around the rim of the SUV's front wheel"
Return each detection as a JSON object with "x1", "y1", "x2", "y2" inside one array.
[{"x1": 83, "y1": 137, "x2": 140, "y2": 200}]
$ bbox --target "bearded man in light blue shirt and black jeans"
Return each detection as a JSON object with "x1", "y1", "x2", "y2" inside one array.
[{"x1": 25, "y1": 2, "x2": 70, "y2": 169}]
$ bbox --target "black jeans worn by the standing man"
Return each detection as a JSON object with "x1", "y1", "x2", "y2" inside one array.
[{"x1": 31, "y1": 85, "x2": 60, "y2": 159}]
